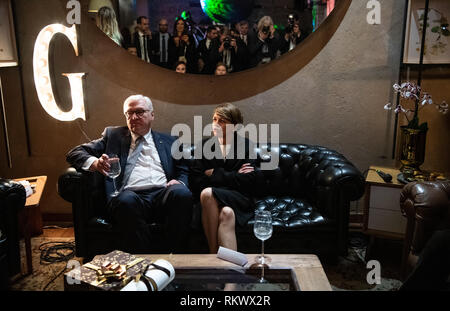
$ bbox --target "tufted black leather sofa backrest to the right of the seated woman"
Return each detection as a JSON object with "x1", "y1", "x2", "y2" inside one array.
[{"x1": 183, "y1": 143, "x2": 363, "y2": 217}]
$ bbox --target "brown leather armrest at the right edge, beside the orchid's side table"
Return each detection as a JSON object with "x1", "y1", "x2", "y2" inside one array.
[{"x1": 400, "y1": 181, "x2": 450, "y2": 255}]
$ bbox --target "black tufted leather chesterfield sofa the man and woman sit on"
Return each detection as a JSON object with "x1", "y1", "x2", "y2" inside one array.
[{"x1": 58, "y1": 144, "x2": 364, "y2": 258}]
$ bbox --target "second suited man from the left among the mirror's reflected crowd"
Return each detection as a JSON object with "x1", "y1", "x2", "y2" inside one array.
[{"x1": 150, "y1": 18, "x2": 176, "y2": 69}]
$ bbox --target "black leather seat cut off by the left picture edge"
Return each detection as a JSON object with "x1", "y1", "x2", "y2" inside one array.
[{"x1": 0, "y1": 178, "x2": 26, "y2": 289}]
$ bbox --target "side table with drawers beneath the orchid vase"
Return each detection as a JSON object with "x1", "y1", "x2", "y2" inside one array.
[{"x1": 363, "y1": 166, "x2": 406, "y2": 259}]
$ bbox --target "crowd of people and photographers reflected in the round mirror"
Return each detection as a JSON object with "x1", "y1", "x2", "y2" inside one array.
[{"x1": 96, "y1": 7, "x2": 326, "y2": 75}]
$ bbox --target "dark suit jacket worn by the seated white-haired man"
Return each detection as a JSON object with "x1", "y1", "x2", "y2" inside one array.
[{"x1": 66, "y1": 126, "x2": 188, "y2": 200}]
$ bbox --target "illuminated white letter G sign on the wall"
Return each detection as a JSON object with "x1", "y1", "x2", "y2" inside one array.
[{"x1": 33, "y1": 24, "x2": 86, "y2": 121}]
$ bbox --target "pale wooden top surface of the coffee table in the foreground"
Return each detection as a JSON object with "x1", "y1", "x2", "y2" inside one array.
[{"x1": 142, "y1": 254, "x2": 332, "y2": 291}]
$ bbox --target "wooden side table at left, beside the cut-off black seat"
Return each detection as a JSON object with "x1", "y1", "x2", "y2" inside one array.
[{"x1": 14, "y1": 176, "x2": 47, "y2": 275}]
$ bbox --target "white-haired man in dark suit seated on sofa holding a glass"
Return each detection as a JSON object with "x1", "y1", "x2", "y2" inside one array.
[{"x1": 67, "y1": 95, "x2": 192, "y2": 253}]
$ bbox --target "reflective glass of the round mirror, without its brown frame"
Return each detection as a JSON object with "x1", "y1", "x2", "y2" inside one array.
[{"x1": 89, "y1": 0, "x2": 339, "y2": 75}]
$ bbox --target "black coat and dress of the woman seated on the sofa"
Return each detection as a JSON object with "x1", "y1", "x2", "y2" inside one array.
[{"x1": 189, "y1": 133, "x2": 260, "y2": 226}]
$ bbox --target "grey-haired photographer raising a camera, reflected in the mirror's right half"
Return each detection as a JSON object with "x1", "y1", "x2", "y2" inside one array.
[{"x1": 248, "y1": 16, "x2": 281, "y2": 67}]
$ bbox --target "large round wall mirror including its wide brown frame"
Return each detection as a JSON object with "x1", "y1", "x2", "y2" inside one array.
[{"x1": 82, "y1": 0, "x2": 351, "y2": 105}]
